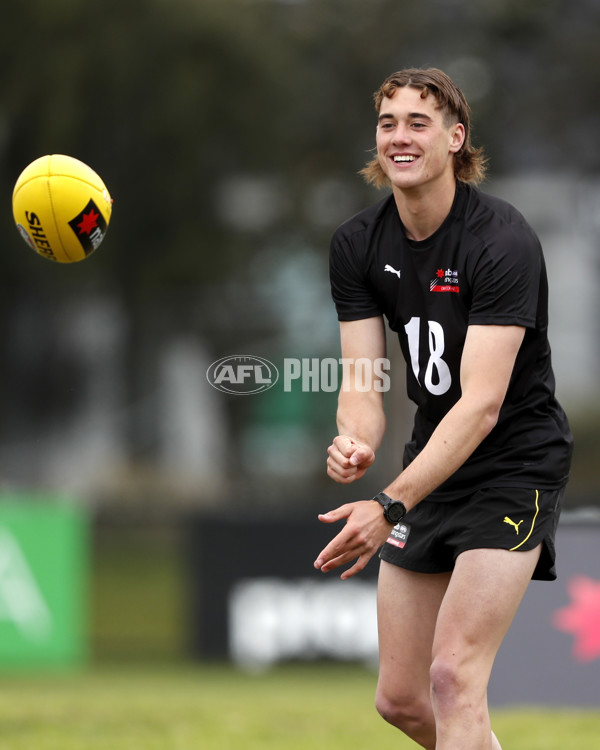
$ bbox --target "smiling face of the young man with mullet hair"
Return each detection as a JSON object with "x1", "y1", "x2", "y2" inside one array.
[{"x1": 376, "y1": 86, "x2": 465, "y2": 197}]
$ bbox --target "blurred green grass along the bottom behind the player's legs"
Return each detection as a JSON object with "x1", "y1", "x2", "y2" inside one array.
[{"x1": 0, "y1": 666, "x2": 600, "y2": 750}]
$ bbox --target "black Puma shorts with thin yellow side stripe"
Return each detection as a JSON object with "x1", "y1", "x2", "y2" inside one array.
[{"x1": 380, "y1": 487, "x2": 564, "y2": 581}]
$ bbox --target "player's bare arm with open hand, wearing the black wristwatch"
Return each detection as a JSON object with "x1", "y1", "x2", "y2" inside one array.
[{"x1": 315, "y1": 326, "x2": 525, "y2": 578}]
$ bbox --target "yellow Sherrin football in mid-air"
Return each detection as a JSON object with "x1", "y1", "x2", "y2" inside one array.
[{"x1": 12, "y1": 154, "x2": 112, "y2": 263}]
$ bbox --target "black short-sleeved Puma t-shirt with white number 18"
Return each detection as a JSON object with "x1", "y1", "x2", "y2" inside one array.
[{"x1": 330, "y1": 183, "x2": 572, "y2": 500}]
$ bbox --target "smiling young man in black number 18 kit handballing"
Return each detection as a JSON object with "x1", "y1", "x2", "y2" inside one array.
[{"x1": 315, "y1": 69, "x2": 572, "y2": 750}]
